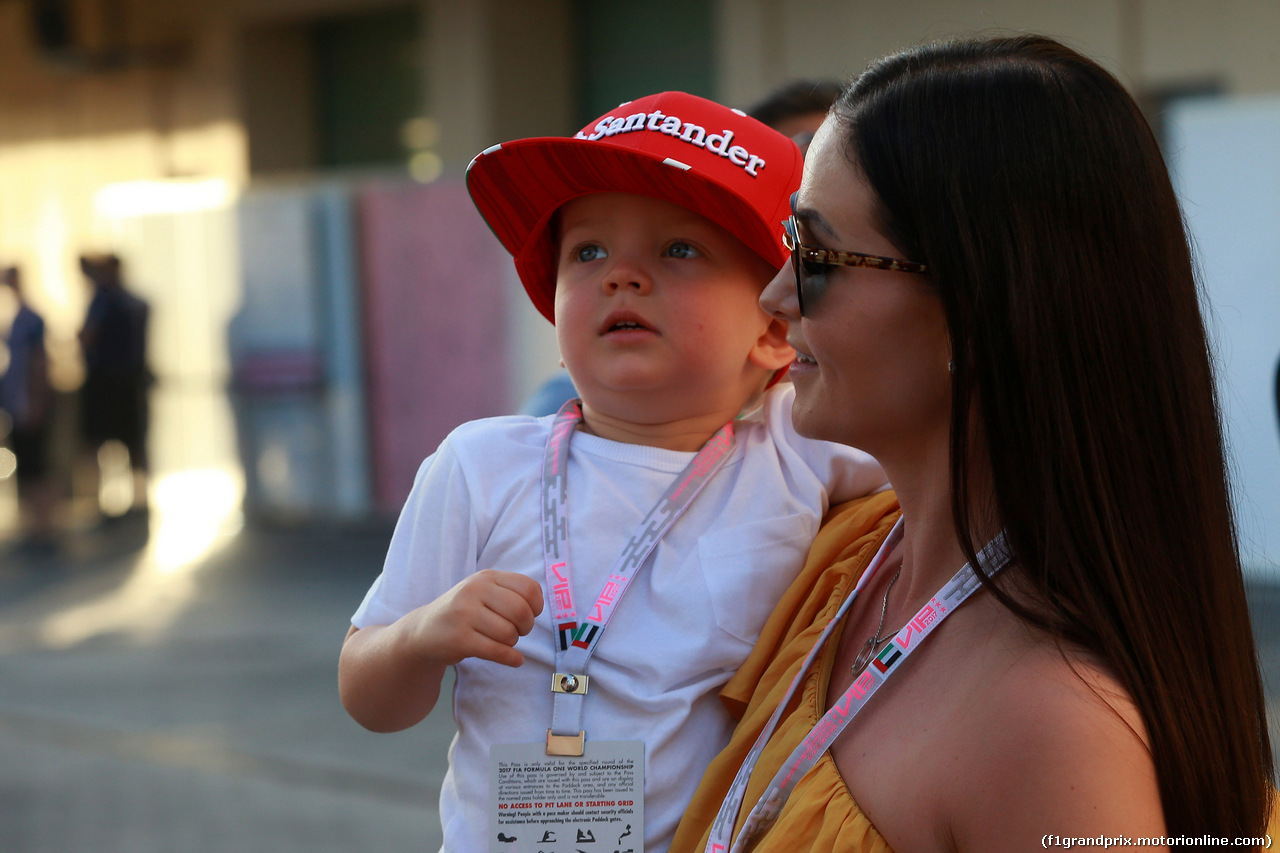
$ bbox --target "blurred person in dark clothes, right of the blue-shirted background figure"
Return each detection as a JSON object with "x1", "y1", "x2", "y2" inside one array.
[{"x1": 79, "y1": 255, "x2": 151, "y2": 511}]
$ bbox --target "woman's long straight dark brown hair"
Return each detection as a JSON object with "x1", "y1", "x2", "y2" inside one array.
[{"x1": 833, "y1": 36, "x2": 1272, "y2": 836}]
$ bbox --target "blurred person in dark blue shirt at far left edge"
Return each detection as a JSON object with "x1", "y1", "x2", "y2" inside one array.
[{"x1": 0, "y1": 266, "x2": 54, "y2": 546}]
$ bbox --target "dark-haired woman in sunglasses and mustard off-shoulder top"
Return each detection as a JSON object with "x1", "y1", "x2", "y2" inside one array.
[{"x1": 672, "y1": 36, "x2": 1272, "y2": 853}]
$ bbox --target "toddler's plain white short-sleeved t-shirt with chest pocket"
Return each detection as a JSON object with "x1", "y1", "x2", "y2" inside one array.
[{"x1": 351, "y1": 386, "x2": 886, "y2": 853}]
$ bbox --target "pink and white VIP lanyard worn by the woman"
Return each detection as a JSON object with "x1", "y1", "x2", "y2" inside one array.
[{"x1": 705, "y1": 519, "x2": 1010, "y2": 853}]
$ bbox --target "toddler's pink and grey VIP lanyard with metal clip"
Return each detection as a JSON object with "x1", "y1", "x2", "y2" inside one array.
[{"x1": 543, "y1": 400, "x2": 733, "y2": 756}]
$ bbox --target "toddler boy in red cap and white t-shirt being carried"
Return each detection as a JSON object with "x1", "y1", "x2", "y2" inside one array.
[{"x1": 339, "y1": 92, "x2": 884, "y2": 853}]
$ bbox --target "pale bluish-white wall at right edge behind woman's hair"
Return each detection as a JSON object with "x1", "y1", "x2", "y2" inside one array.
[{"x1": 1169, "y1": 96, "x2": 1280, "y2": 580}]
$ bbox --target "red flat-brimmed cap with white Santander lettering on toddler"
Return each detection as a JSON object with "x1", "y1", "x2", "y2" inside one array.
[{"x1": 467, "y1": 92, "x2": 804, "y2": 323}]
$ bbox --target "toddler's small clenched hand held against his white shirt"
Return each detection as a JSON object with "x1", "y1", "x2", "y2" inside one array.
[{"x1": 413, "y1": 569, "x2": 543, "y2": 666}]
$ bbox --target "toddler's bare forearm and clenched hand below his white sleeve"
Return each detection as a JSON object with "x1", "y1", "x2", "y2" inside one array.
[{"x1": 338, "y1": 569, "x2": 543, "y2": 731}]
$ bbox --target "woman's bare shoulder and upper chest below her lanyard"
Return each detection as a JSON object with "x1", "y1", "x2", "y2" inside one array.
[{"x1": 832, "y1": 594, "x2": 1165, "y2": 853}]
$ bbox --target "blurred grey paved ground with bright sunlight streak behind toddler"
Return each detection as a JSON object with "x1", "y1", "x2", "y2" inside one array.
[{"x1": 0, "y1": 520, "x2": 1280, "y2": 853}]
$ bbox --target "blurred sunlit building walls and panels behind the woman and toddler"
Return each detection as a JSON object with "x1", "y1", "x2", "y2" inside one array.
[{"x1": 0, "y1": 0, "x2": 1280, "y2": 578}]
